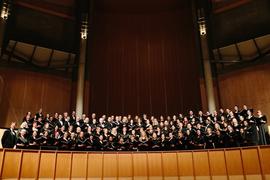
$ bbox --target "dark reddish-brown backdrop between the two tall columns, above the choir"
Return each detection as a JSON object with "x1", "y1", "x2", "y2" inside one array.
[{"x1": 88, "y1": 0, "x2": 201, "y2": 116}]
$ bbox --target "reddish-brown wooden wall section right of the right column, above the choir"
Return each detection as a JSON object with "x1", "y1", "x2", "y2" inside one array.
[{"x1": 218, "y1": 63, "x2": 270, "y2": 121}]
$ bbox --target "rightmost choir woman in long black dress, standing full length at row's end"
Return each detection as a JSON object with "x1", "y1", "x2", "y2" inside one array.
[{"x1": 256, "y1": 110, "x2": 269, "y2": 145}]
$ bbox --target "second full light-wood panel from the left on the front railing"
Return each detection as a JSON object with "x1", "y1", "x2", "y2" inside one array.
[{"x1": 20, "y1": 151, "x2": 39, "y2": 179}]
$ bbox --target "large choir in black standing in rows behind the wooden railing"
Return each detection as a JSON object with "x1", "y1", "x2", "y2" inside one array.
[{"x1": 2, "y1": 105, "x2": 268, "y2": 151}]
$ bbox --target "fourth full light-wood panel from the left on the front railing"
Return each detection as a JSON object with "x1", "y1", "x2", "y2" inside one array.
[{"x1": 55, "y1": 153, "x2": 71, "y2": 179}]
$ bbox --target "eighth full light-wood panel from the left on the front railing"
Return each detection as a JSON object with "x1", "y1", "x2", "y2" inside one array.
[{"x1": 118, "y1": 154, "x2": 133, "y2": 178}]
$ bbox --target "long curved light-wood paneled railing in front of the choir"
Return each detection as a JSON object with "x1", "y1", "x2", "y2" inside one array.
[{"x1": 0, "y1": 146, "x2": 270, "y2": 180}]
